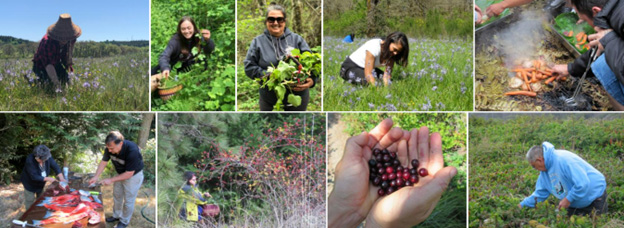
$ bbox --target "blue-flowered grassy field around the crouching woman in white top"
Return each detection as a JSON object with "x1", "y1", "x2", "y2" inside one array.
[{"x1": 323, "y1": 36, "x2": 473, "y2": 111}]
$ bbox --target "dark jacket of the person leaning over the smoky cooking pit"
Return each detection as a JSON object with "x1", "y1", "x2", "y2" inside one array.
[{"x1": 568, "y1": 0, "x2": 624, "y2": 84}]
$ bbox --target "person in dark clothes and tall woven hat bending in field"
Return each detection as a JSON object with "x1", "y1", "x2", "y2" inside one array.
[{"x1": 32, "y1": 14, "x2": 82, "y2": 92}]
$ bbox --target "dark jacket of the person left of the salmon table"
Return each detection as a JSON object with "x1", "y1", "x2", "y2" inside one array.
[{"x1": 20, "y1": 154, "x2": 61, "y2": 192}]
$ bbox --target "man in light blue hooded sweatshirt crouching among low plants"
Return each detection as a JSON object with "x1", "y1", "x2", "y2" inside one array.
[{"x1": 518, "y1": 142, "x2": 607, "y2": 216}]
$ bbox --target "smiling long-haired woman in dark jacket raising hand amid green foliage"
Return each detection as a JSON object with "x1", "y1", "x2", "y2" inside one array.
[{"x1": 150, "y1": 16, "x2": 215, "y2": 91}]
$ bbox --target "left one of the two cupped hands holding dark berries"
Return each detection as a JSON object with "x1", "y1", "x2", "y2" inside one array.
[{"x1": 327, "y1": 119, "x2": 405, "y2": 227}]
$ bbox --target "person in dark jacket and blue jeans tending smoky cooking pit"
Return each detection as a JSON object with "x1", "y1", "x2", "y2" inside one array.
[{"x1": 553, "y1": 0, "x2": 624, "y2": 111}]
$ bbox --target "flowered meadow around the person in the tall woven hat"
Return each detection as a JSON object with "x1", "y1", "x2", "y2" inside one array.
[{"x1": 0, "y1": 54, "x2": 149, "y2": 111}]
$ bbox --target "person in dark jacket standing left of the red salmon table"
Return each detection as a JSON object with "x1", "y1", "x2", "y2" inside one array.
[{"x1": 20, "y1": 145, "x2": 66, "y2": 210}]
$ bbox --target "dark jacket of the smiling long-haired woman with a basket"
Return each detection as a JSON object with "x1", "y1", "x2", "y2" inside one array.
[{"x1": 158, "y1": 34, "x2": 215, "y2": 71}]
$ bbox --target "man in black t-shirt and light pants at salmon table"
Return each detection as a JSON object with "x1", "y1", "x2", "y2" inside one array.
[{"x1": 89, "y1": 131, "x2": 143, "y2": 228}]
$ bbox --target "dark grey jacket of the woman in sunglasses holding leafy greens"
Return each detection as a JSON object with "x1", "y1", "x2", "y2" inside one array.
[{"x1": 243, "y1": 28, "x2": 318, "y2": 88}]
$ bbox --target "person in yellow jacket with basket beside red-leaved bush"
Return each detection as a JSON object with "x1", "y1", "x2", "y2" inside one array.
[{"x1": 178, "y1": 171, "x2": 219, "y2": 222}]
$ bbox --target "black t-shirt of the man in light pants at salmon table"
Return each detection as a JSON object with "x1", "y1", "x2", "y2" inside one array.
[{"x1": 102, "y1": 140, "x2": 143, "y2": 175}]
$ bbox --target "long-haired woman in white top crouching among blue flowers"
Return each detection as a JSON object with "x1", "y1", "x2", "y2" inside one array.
[{"x1": 340, "y1": 32, "x2": 409, "y2": 86}]
